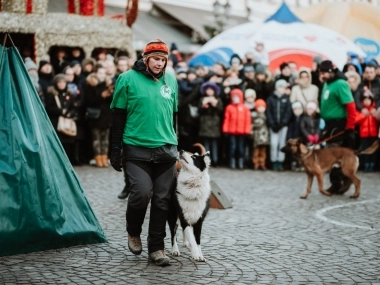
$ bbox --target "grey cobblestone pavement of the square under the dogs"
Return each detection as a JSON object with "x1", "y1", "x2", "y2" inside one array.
[{"x1": 0, "y1": 167, "x2": 380, "y2": 284}]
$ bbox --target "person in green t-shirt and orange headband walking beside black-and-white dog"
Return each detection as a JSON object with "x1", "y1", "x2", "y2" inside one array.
[{"x1": 107, "y1": 39, "x2": 178, "y2": 266}]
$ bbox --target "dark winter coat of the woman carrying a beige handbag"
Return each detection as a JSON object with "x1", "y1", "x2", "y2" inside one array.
[{"x1": 45, "y1": 86, "x2": 77, "y2": 143}]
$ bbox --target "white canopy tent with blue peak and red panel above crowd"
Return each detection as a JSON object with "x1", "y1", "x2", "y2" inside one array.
[{"x1": 189, "y1": 3, "x2": 365, "y2": 71}]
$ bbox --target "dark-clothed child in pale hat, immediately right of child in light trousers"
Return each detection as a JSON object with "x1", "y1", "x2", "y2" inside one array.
[{"x1": 286, "y1": 101, "x2": 304, "y2": 171}]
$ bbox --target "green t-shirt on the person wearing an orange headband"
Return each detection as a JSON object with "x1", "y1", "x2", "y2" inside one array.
[{"x1": 111, "y1": 70, "x2": 178, "y2": 148}]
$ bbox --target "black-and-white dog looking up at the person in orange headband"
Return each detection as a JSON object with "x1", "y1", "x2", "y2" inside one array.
[{"x1": 168, "y1": 144, "x2": 211, "y2": 262}]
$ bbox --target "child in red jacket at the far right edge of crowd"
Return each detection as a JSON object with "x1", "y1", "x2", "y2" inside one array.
[{"x1": 356, "y1": 87, "x2": 379, "y2": 172}]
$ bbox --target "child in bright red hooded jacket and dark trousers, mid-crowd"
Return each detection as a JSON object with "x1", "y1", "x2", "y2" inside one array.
[{"x1": 223, "y1": 88, "x2": 252, "y2": 169}]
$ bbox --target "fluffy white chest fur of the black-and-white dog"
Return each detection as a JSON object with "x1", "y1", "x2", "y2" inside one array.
[{"x1": 177, "y1": 171, "x2": 211, "y2": 225}]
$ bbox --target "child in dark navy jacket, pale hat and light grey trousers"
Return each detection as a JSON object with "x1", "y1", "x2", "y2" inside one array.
[{"x1": 266, "y1": 79, "x2": 292, "y2": 171}]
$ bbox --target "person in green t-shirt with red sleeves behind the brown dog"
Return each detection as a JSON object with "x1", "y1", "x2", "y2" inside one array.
[{"x1": 319, "y1": 60, "x2": 358, "y2": 194}]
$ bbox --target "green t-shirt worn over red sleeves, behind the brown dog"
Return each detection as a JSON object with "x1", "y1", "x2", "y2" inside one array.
[{"x1": 321, "y1": 79, "x2": 354, "y2": 121}]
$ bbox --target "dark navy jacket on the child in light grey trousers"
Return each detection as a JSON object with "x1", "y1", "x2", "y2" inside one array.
[{"x1": 266, "y1": 93, "x2": 293, "y2": 132}]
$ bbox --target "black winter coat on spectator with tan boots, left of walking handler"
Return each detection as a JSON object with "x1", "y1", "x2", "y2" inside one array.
[{"x1": 83, "y1": 73, "x2": 112, "y2": 130}]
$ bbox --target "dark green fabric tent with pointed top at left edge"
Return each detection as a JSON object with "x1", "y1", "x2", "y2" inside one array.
[{"x1": 0, "y1": 40, "x2": 107, "y2": 256}]
